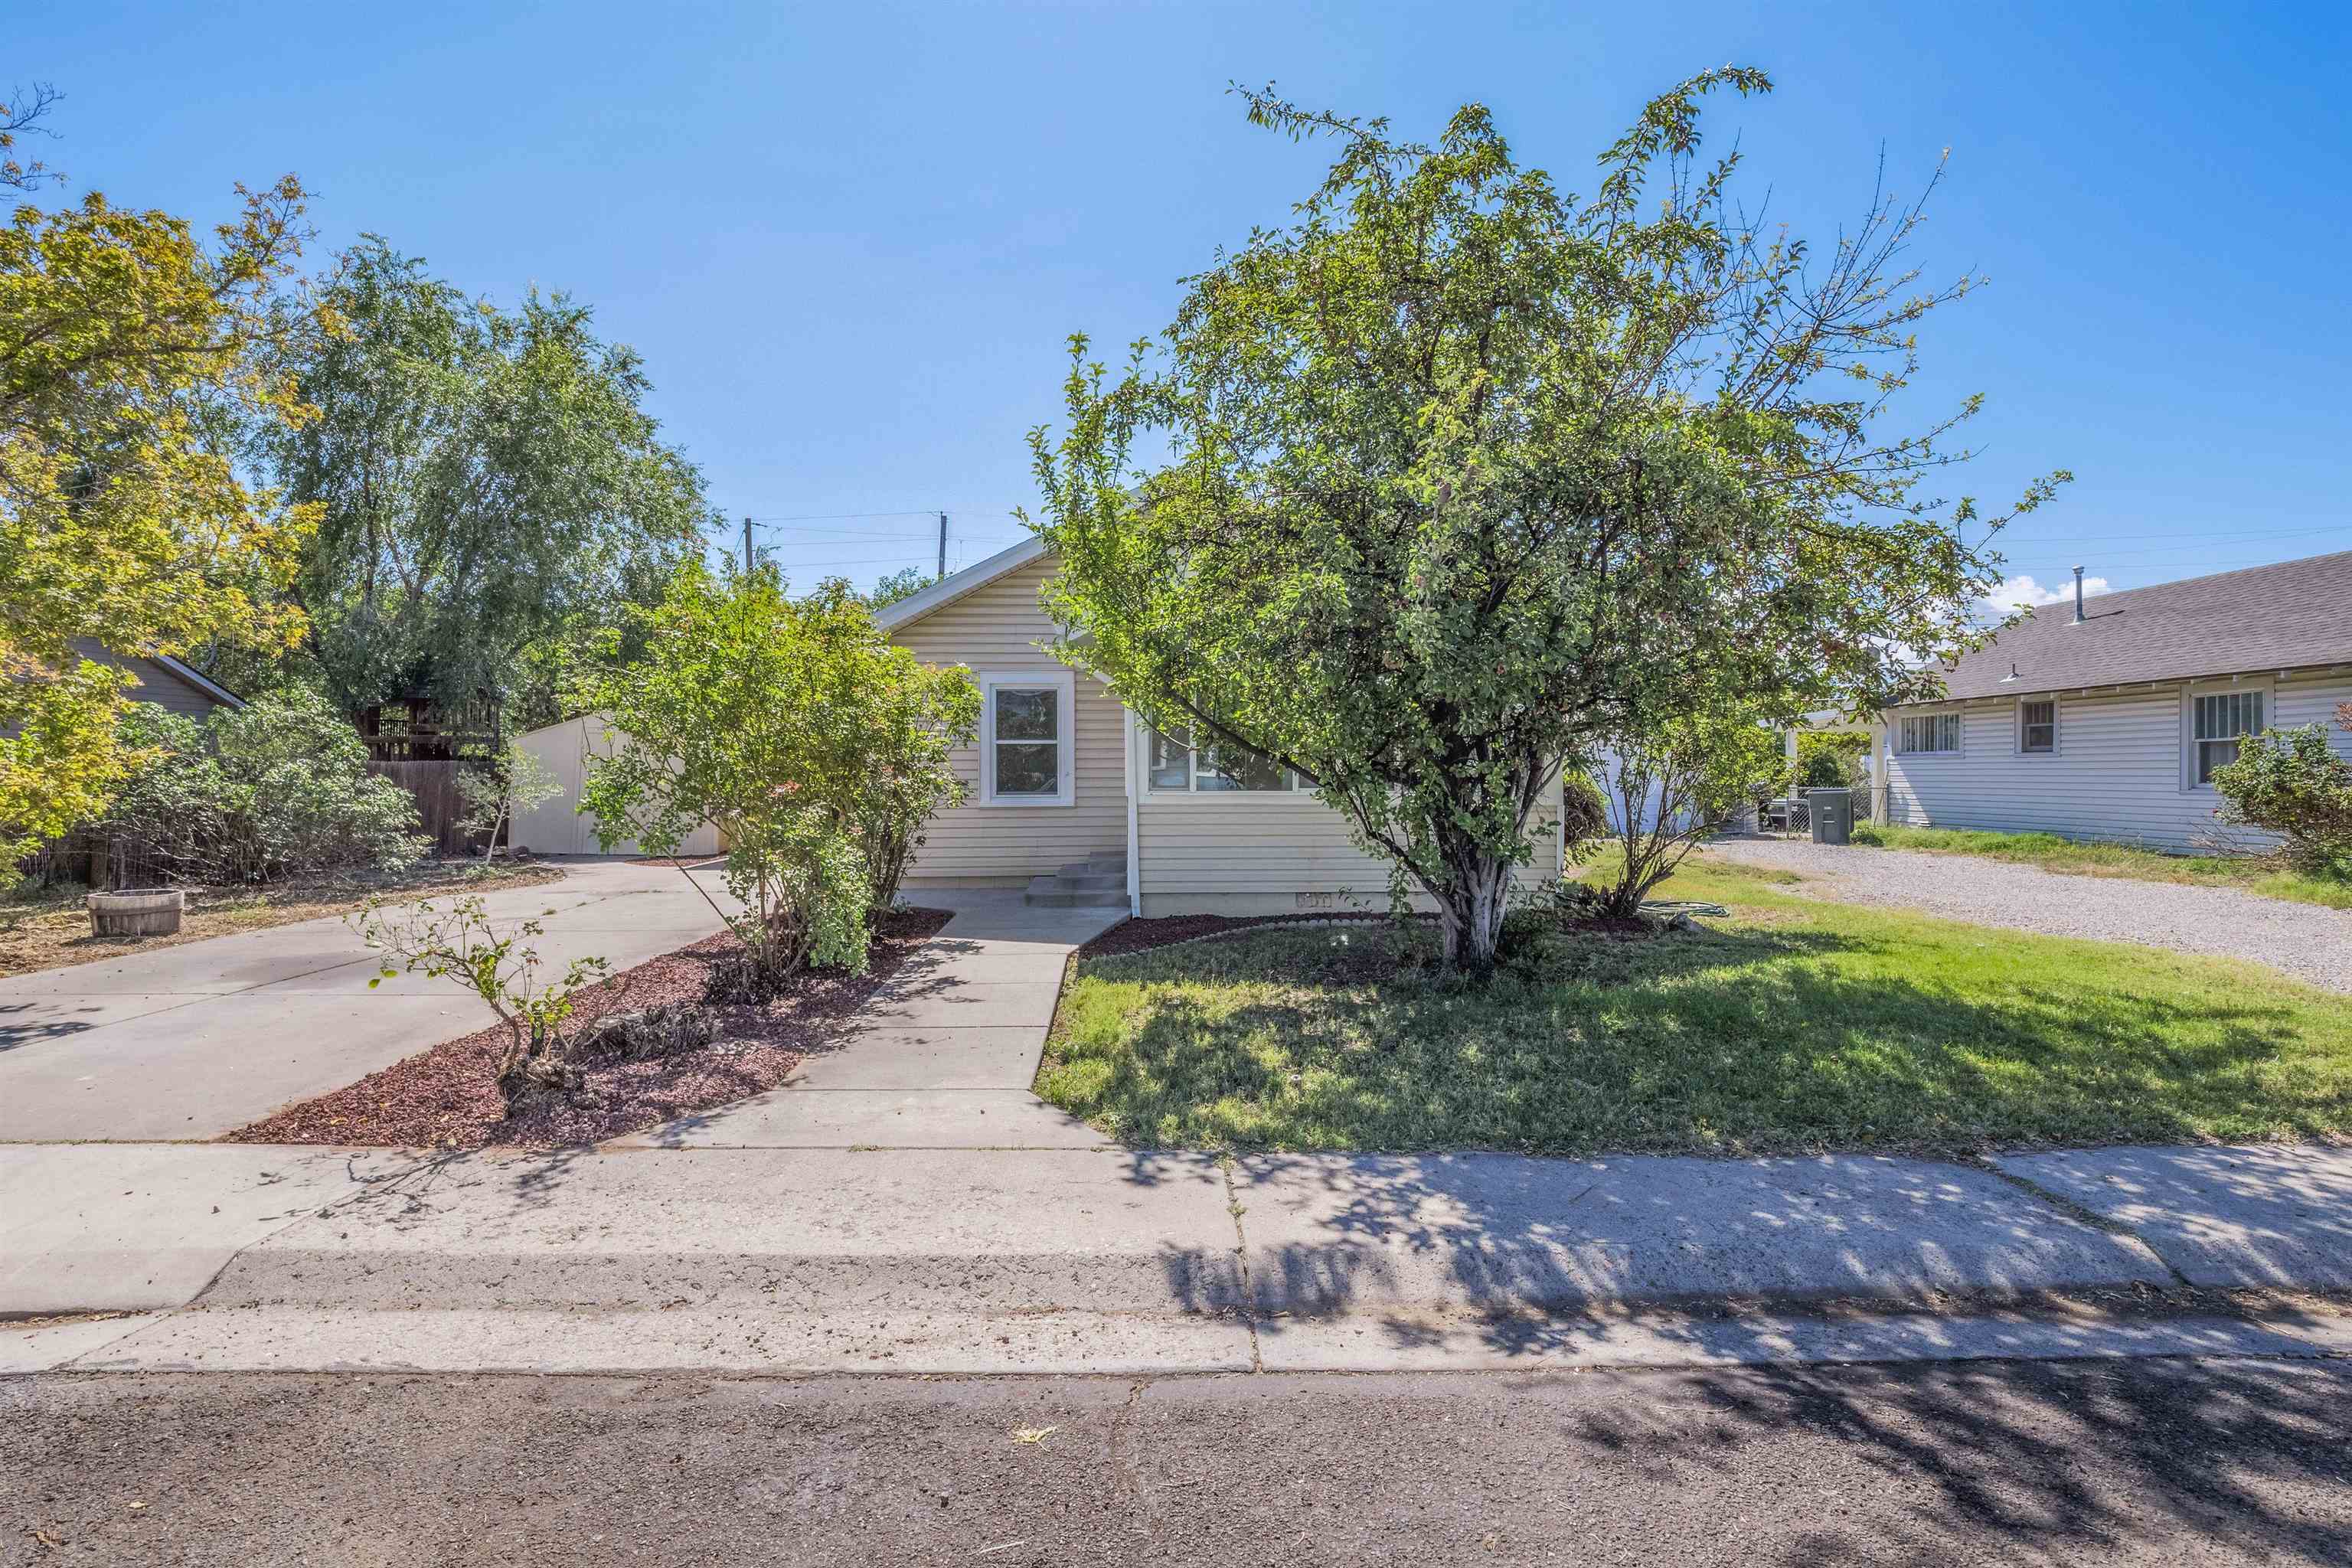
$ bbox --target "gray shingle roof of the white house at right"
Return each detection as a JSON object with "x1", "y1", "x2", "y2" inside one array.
[{"x1": 1942, "y1": 550, "x2": 2352, "y2": 698}]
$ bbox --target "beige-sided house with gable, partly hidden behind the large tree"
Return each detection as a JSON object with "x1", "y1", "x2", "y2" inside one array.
[{"x1": 875, "y1": 538, "x2": 1560, "y2": 916}]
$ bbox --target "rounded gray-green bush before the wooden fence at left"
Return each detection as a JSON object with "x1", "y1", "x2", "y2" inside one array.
[{"x1": 96, "y1": 691, "x2": 428, "y2": 887}]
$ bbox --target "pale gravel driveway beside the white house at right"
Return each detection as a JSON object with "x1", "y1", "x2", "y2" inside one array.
[{"x1": 1705, "y1": 839, "x2": 2352, "y2": 992}]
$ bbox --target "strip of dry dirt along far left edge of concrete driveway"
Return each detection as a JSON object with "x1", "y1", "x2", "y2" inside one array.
[{"x1": 0, "y1": 861, "x2": 564, "y2": 975}]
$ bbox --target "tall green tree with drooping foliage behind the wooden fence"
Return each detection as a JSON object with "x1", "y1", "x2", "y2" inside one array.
[{"x1": 263, "y1": 237, "x2": 708, "y2": 724}]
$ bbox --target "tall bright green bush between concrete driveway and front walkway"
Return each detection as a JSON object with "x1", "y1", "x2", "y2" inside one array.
[{"x1": 579, "y1": 562, "x2": 981, "y2": 995}]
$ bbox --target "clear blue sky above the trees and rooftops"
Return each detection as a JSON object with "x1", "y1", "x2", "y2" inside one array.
[{"x1": 22, "y1": 0, "x2": 2352, "y2": 606}]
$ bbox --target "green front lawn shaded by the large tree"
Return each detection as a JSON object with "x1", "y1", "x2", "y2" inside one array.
[{"x1": 1037, "y1": 865, "x2": 2352, "y2": 1155}]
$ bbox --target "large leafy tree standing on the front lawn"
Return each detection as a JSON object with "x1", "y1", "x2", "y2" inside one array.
[{"x1": 1033, "y1": 83, "x2": 2047, "y2": 971}]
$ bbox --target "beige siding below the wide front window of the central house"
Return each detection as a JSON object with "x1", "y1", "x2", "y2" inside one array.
[{"x1": 1136, "y1": 773, "x2": 1560, "y2": 920}]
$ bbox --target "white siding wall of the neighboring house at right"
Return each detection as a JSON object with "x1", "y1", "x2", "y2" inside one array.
[{"x1": 1886, "y1": 670, "x2": 2352, "y2": 851}]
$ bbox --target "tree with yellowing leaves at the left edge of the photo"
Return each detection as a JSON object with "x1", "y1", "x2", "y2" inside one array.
[{"x1": 0, "y1": 96, "x2": 315, "y2": 861}]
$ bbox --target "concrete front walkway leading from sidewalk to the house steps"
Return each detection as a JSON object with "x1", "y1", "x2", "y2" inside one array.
[{"x1": 619, "y1": 889, "x2": 1126, "y2": 1149}]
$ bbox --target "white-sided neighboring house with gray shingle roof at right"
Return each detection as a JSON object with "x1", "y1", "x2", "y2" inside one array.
[{"x1": 1877, "y1": 550, "x2": 2352, "y2": 851}]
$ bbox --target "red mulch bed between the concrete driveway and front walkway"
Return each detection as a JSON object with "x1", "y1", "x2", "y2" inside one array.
[{"x1": 224, "y1": 910, "x2": 950, "y2": 1149}]
